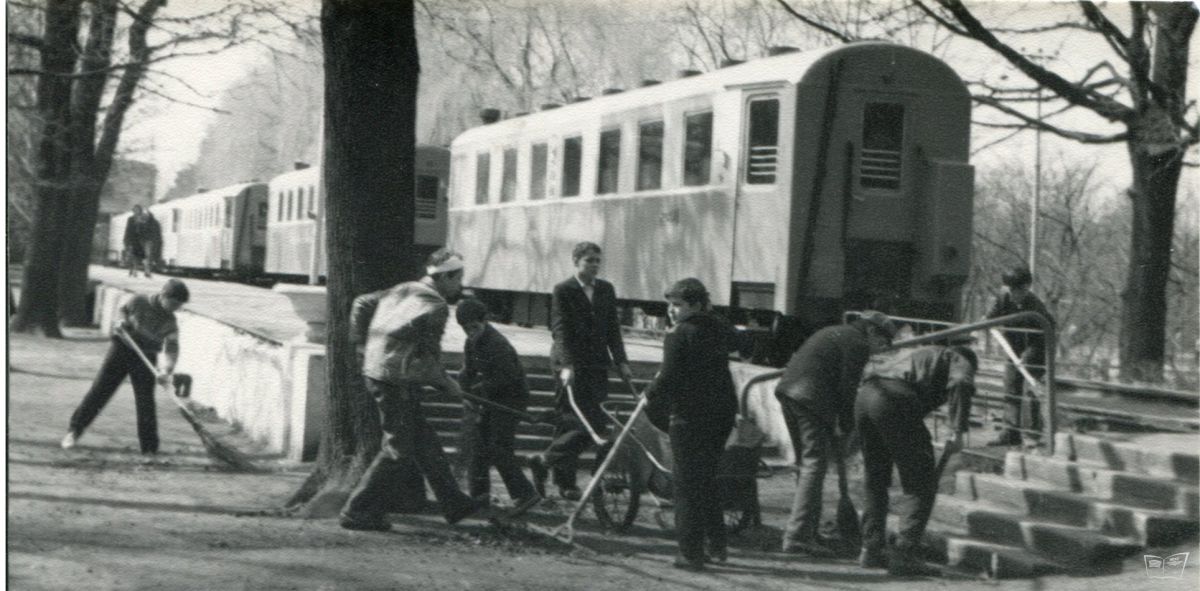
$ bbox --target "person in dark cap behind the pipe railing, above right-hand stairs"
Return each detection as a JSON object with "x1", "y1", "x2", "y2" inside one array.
[{"x1": 986, "y1": 264, "x2": 1054, "y2": 446}]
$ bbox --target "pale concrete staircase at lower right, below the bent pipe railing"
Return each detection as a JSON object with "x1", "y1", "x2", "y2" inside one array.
[{"x1": 926, "y1": 434, "x2": 1200, "y2": 578}]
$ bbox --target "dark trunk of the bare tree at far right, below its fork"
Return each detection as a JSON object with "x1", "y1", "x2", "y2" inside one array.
[{"x1": 1121, "y1": 142, "x2": 1183, "y2": 382}]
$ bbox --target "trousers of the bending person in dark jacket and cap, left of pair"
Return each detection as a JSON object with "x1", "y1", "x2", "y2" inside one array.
[{"x1": 775, "y1": 395, "x2": 834, "y2": 547}]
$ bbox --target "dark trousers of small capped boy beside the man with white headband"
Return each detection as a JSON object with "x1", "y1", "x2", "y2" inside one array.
[{"x1": 467, "y1": 411, "x2": 534, "y2": 501}]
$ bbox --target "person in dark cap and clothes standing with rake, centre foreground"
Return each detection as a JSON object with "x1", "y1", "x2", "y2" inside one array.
[{"x1": 646, "y1": 277, "x2": 738, "y2": 571}]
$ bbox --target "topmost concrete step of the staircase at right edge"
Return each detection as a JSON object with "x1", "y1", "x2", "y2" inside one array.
[{"x1": 1055, "y1": 432, "x2": 1200, "y2": 484}]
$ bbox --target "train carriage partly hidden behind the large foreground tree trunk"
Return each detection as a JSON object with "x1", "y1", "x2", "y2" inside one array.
[{"x1": 265, "y1": 145, "x2": 450, "y2": 277}]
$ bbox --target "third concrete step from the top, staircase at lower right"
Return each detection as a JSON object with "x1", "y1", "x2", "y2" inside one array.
[{"x1": 956, "y1": 472, "x2": 1200, "y2": 547}]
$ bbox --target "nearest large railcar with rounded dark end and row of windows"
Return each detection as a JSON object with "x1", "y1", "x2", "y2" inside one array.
[{"x1": 449, "y1": 42, "x2": 974, "y2": 355}]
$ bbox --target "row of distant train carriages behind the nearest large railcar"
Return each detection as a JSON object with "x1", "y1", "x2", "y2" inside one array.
[{"x1": 107, "y1": 145, "x2": 450, "y2": 281}]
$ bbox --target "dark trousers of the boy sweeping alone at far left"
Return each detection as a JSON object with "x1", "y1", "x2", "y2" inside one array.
[{"x1": 71, "y1": 336, "x2": 158, "y2": 453}]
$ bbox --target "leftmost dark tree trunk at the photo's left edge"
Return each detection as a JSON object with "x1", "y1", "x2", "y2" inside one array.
[{"x1": 11, "y1": 0, "x2": 82, "y2": 338}]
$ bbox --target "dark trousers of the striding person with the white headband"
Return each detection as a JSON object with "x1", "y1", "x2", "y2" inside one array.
[{"x1": 346, "y1": 378, "x2": 470, "y2": 517}]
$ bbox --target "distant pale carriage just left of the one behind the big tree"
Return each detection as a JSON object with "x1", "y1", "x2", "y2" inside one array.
[{"x1": 150, "y1": 183, "x2": 268, "y2": 276}]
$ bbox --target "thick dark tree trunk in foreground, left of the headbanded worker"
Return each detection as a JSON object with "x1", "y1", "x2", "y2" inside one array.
[{"x1": 288, "y1": 0, "x2": 420, "y2": 518}]
